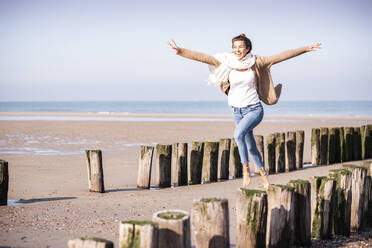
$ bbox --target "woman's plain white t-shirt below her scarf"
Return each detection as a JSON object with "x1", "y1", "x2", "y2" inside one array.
[{"x1": 228, "y1": 68, "x2": 260, "y2": 108}]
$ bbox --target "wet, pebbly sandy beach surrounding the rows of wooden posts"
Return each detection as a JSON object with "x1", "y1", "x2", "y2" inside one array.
[{"x1": 0, "y1": 112, "x2": 372, "y2": 247}]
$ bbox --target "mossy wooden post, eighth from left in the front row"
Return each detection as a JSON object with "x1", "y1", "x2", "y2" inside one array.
[{"x1": 311, "y1": 177, "x2": 336, "y2": 239}]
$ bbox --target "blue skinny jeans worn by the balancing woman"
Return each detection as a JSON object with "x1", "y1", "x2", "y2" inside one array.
[{"x1": 232, "y1": 102, "x2": 264, "y2": 170}]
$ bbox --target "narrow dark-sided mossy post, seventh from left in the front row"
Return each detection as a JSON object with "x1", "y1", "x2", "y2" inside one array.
[{"x1": 288, "y1": 180, "x2": 311, "y2": 247}]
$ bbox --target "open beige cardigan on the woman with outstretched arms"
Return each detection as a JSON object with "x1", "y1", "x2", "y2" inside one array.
[{"x1": 177, "y1": 47, "x2": 309, "y2": 105}]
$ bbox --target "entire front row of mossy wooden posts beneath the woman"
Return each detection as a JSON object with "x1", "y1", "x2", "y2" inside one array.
[{"x1": 68, "y1": 161, "x2": 372, "y2": 248}]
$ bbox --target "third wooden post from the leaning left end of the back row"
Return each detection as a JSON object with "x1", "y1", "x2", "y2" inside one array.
[{"x1": 172, "y1": 143, "x2": 188, "y2": 186}]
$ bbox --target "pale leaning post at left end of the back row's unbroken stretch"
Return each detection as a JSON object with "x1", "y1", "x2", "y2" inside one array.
[{"x1": 137, "y1": 146, "x2": 154, "y2": 189}]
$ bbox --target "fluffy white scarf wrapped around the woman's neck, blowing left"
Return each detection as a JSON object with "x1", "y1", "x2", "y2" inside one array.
[{"x1": 208, "y1": 53, "x2": 256, "y2": 86}]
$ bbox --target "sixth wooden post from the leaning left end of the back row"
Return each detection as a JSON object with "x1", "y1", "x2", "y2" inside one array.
[{"x1": 217, "y1": 139, "x2": 231, "y2": 180}]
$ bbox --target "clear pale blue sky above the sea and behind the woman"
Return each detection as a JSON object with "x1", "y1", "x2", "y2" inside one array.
[{"x1": 0, "y1": 0, "x2": 372, "y2": 101}]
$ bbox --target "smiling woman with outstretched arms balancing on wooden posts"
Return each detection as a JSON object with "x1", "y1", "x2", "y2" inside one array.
[{"x1": 169, "y1": 34, "x2": 321, "y2": 189}]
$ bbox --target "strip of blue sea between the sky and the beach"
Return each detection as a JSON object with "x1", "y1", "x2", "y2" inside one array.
[{"x1": 0, "y1": 101, "x2": 372, "y2": 117}]
